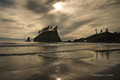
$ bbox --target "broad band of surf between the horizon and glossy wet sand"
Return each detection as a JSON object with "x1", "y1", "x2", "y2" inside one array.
[{"x1": 0, "y1": 42, "x2": 120, "y2": 58}]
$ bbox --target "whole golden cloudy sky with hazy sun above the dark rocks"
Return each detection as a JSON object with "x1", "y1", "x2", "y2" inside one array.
[{"x1": 0, "y1": 0, "x2": 120, "y2": 40}]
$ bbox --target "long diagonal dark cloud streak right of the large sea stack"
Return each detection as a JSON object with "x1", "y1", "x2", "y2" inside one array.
[{"x1": 60, "y1": 18, "x2": 97, "y2": 35}]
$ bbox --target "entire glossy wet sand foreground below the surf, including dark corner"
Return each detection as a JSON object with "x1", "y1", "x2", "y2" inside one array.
[{"x1": 0, "y1": 51, "x2": 120, "y2": 80}]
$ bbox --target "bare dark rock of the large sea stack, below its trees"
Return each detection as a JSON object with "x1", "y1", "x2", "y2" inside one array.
[{"x1": 34, "y1": 27, "x2": 62, "y2": 42}]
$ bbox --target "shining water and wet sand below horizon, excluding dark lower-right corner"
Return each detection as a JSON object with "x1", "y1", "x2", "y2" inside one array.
[{"x1": 0, "y1": 41, "x2": 120, "y2": 80}]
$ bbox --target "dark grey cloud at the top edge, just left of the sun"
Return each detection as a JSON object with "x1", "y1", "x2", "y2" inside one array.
[{"x1": 25, "y1": 0, "x2": 64, "y2": 13}]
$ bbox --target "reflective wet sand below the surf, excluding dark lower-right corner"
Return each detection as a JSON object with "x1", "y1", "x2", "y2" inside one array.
[{"x1": 0, "y1": 43, "x2": 120, "y2": 80}]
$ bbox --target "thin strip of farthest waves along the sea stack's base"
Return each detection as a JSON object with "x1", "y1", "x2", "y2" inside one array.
[{"x1": 0, "y1": 42, "x2": 120, "y2": 47}]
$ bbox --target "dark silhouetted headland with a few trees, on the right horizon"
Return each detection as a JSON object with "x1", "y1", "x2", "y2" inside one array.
[{"x1": 73, "y1": 28, "x2": 120, "y2": 43}]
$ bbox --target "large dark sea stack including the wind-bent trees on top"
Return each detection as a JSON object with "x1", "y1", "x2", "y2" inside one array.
[{"x1": 34, "y1": 26, "x2": 62, "y2": 42}]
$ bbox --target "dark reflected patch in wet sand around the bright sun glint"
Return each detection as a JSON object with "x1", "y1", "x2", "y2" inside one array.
[{"x1": 27, "y1": 58, "x2": 70, "y2": 80}]
